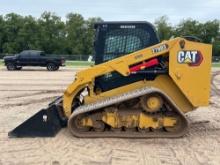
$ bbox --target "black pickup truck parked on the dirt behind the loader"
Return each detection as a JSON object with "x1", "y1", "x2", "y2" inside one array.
[{"x1": 3, "y1": 50, "x2": 65, "y2": 71}]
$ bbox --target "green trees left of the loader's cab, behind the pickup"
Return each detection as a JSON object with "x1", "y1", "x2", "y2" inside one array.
[{"x1": 0, "y1": 12, "x2": 102, "y2": 55}]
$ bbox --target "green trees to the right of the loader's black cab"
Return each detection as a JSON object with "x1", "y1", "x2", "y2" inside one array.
[{"x1": 154, "y1": 16, "x2": 220, "y2": 57}]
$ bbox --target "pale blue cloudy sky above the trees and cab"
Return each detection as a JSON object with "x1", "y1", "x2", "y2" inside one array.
[{"x1": 0, "y1": 0, "x2": 220, "y2": 24}]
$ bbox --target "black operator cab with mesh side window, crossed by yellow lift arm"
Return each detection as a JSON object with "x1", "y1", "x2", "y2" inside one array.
[{"x1": 94, "y1": 22, "x2": 159, "y2": 91}]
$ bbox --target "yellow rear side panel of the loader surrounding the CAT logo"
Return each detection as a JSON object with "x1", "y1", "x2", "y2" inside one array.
[{"x1": 169, "y1": 40, "x2": 212, "y2": 107}]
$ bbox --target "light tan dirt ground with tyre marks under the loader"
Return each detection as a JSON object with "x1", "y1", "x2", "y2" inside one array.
[{"x1": 0, "y1": 67, "x2": 220, "y2": 165}]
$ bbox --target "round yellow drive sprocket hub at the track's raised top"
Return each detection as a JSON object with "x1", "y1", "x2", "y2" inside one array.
[{"x1": 141, "y1": 94, "x2": 163, "y2": 113}]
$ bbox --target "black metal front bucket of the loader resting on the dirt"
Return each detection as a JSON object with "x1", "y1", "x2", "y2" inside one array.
[{"x1": 8, "y1": 104, "x2": 66, "y2": 137}]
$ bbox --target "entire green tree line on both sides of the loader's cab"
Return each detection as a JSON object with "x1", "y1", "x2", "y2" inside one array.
[{"x1": 0, "y1": 12, "x2": 220, "y2": 56}]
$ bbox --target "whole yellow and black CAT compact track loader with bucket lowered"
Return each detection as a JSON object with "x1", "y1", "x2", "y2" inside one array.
[{"x1": 9, "y1": 22, "x2": 212, "y2": 138}]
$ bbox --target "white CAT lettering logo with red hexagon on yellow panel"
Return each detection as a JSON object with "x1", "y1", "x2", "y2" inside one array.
[{"x1": 177, "y1": 50, "x2": 203, "y2": 66}]
